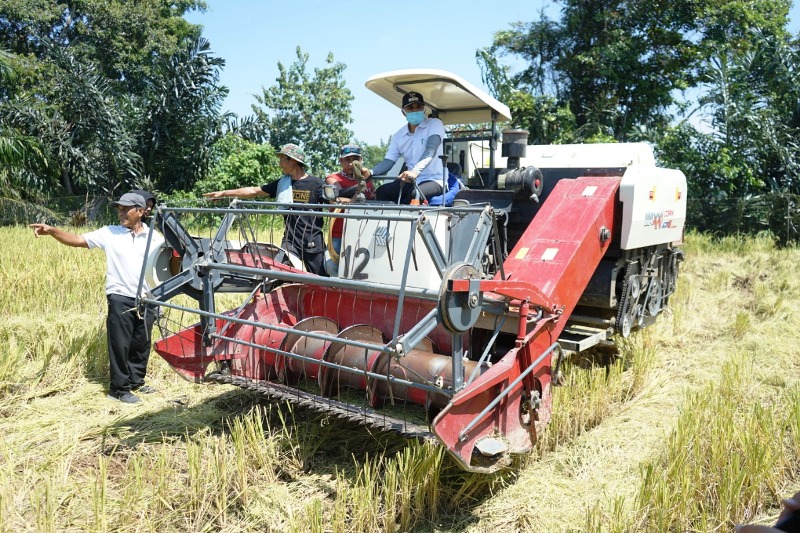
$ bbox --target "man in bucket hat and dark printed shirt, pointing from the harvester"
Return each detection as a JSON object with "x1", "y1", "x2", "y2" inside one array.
[{"x1": 203, "y1": 144, "x2": 326, "y2": 276}]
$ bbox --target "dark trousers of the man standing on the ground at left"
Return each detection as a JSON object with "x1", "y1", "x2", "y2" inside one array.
[{"x1": 106, "y1": 294, "x2": 156, "y2": 397}]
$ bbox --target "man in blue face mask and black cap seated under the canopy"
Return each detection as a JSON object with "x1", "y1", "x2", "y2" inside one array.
[{"x1": 363, "y1": 91, "x2": 445, "y2": 204}]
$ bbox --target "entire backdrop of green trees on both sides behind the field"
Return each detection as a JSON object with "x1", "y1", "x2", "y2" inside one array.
[{"x1": 0, "y1": 0, "x2": 800, "y2": 235}]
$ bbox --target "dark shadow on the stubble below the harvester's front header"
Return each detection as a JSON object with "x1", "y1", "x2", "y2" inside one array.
[{"x1": 103, "y1": 382, "x2": 516, "y2": 531}]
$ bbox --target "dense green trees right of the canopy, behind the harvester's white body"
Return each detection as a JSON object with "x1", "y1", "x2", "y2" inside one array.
[{"x1": 478, "y1": 0, "x2": 800, "y2": 204}]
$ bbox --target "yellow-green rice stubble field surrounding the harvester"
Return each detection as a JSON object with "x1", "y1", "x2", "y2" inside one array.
[{"x1": 0, "y1": 223, "x2": 800, "y2": 532}]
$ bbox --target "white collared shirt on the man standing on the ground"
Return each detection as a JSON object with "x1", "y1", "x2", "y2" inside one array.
[{"x1": 83, "y1": 224, "x2": 164, "y2": 298}]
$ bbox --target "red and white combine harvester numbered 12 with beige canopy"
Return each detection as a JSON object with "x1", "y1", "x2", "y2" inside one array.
[{"x1": 141, "y1": 70, "x2": 687, "y2": 473}]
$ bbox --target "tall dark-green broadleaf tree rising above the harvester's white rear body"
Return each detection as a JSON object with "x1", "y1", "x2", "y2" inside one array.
[{"x1": 481, "y1": 0, "x2": 790, "y2": 141}]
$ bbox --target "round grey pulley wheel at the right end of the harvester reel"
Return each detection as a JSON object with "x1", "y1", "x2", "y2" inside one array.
[{"x1": 439, "y1": 262, "x2": 482, "y2": 333}]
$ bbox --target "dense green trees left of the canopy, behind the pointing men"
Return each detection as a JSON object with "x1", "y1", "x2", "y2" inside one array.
[{"x1": 0, "y1": 0, "x2": 360, "y2": 206}]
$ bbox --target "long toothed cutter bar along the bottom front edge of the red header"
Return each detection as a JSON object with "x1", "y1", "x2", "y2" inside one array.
[{"x1": 204, "y1": 373, "x2": 436, "y2": 440}]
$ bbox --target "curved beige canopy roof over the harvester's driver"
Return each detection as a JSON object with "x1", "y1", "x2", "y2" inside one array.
[{"x1": 364, "y1": 69, "x2": 511, "y2": 125}]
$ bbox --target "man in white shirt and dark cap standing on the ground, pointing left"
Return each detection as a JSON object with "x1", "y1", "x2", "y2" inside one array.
[{"x1": 30, "y1": 193, "x2": 164, "y2": 403}]
